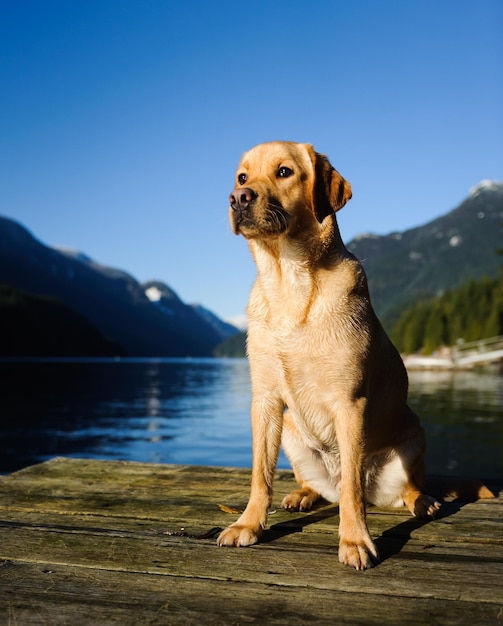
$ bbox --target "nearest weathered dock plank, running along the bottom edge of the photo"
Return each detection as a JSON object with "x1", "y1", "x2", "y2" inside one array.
[{"x1": 0, "y1": 563, "x2": 501, "y2": 626}]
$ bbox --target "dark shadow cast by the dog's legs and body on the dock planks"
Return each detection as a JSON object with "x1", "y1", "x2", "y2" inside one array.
[{"x1": 260, "y1": 500, "x2": 476, "y2": 563}]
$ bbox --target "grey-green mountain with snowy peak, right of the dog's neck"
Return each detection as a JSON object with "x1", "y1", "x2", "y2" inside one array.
[{"x1": 347, "y1": 181, "x2": 503, "y2": 330}]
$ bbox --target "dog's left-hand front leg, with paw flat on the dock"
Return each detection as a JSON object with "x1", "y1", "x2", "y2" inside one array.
[{"x1": 217, "y1": 398, "x2": 284, "y2": 547}]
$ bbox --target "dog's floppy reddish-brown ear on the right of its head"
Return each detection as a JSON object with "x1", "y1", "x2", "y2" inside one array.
[{"x1": 311, "y1": 149, "x2": 352, "y2": 224}]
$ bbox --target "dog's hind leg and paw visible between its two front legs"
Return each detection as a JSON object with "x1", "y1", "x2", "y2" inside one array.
[{"x1": 281, "y1": 411, "x2": 339, "y2": 511}]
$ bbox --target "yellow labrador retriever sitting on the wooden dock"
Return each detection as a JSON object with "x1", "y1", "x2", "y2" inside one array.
[{"x1": 218, "y1": 142, "x2": 476, "y2": 569}]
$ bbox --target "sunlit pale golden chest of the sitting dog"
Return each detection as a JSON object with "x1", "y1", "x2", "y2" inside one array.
[{"x1": 248, "y1": 254, "x2": 361, "y2": 452}]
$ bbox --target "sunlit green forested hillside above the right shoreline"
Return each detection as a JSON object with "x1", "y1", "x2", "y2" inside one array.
[{"x1": 391, "y1": 272, "x2": 503, "y2": 354}]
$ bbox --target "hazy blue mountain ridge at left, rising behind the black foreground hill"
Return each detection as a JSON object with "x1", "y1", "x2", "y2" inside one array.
[{"x1": 0, "y1": 217, "x2": 236, "y2": 356}]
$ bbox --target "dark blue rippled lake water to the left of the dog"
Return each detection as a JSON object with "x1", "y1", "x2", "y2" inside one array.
[{"x1": 0, "y1": 359, "x2": 250, "y2": 472}]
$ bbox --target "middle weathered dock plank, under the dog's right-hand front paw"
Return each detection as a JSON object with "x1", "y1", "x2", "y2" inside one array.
[{"x1": 0, "y1": 526, "x2": 503, "y2": 602}]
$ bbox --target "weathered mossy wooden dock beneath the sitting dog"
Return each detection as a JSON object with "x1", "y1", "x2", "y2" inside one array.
[{"x1": 0, "y1": 458, "x2": 503, "y2": 626}]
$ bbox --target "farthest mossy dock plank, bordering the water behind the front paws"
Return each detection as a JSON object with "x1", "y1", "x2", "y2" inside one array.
[{"x1": 0, "y1": 459, "x2": 503, "y2": 544}]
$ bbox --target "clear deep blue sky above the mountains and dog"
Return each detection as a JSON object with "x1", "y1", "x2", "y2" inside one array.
[{"x1": 0, "y1": 0, "x2": 503, "y2": 318}]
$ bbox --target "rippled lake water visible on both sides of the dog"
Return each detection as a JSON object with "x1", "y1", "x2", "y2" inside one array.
[{"x1": 0, "y1": 359, "x2": 503, "y2": 478}]
